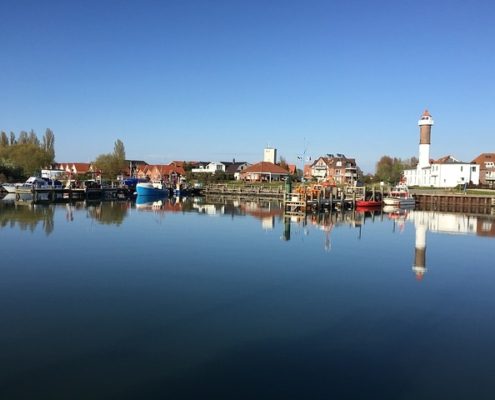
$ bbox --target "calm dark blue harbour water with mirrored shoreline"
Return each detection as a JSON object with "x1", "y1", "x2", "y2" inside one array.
[{"x1": 0, "y1": 193, "x2": 495, "y2": 399}]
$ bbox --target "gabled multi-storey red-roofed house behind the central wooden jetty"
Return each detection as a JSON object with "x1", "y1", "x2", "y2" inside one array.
[{"x1": 305, "y1": 153, "x2": 358, "y2": 185}]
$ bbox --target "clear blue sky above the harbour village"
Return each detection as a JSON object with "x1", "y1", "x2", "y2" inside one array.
[{"x1": 0, "y1": 0, "x2": 495, "y2": 172}]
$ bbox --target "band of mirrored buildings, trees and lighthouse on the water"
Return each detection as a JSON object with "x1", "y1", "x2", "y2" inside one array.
[{"x1": 0, "y1": 195, "x2": 495, "y2": 250}]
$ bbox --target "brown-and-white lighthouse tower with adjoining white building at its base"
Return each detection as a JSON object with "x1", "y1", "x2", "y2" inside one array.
[{"x1": 404, "y1": 110, "x2": 480, "y2": 188}]
